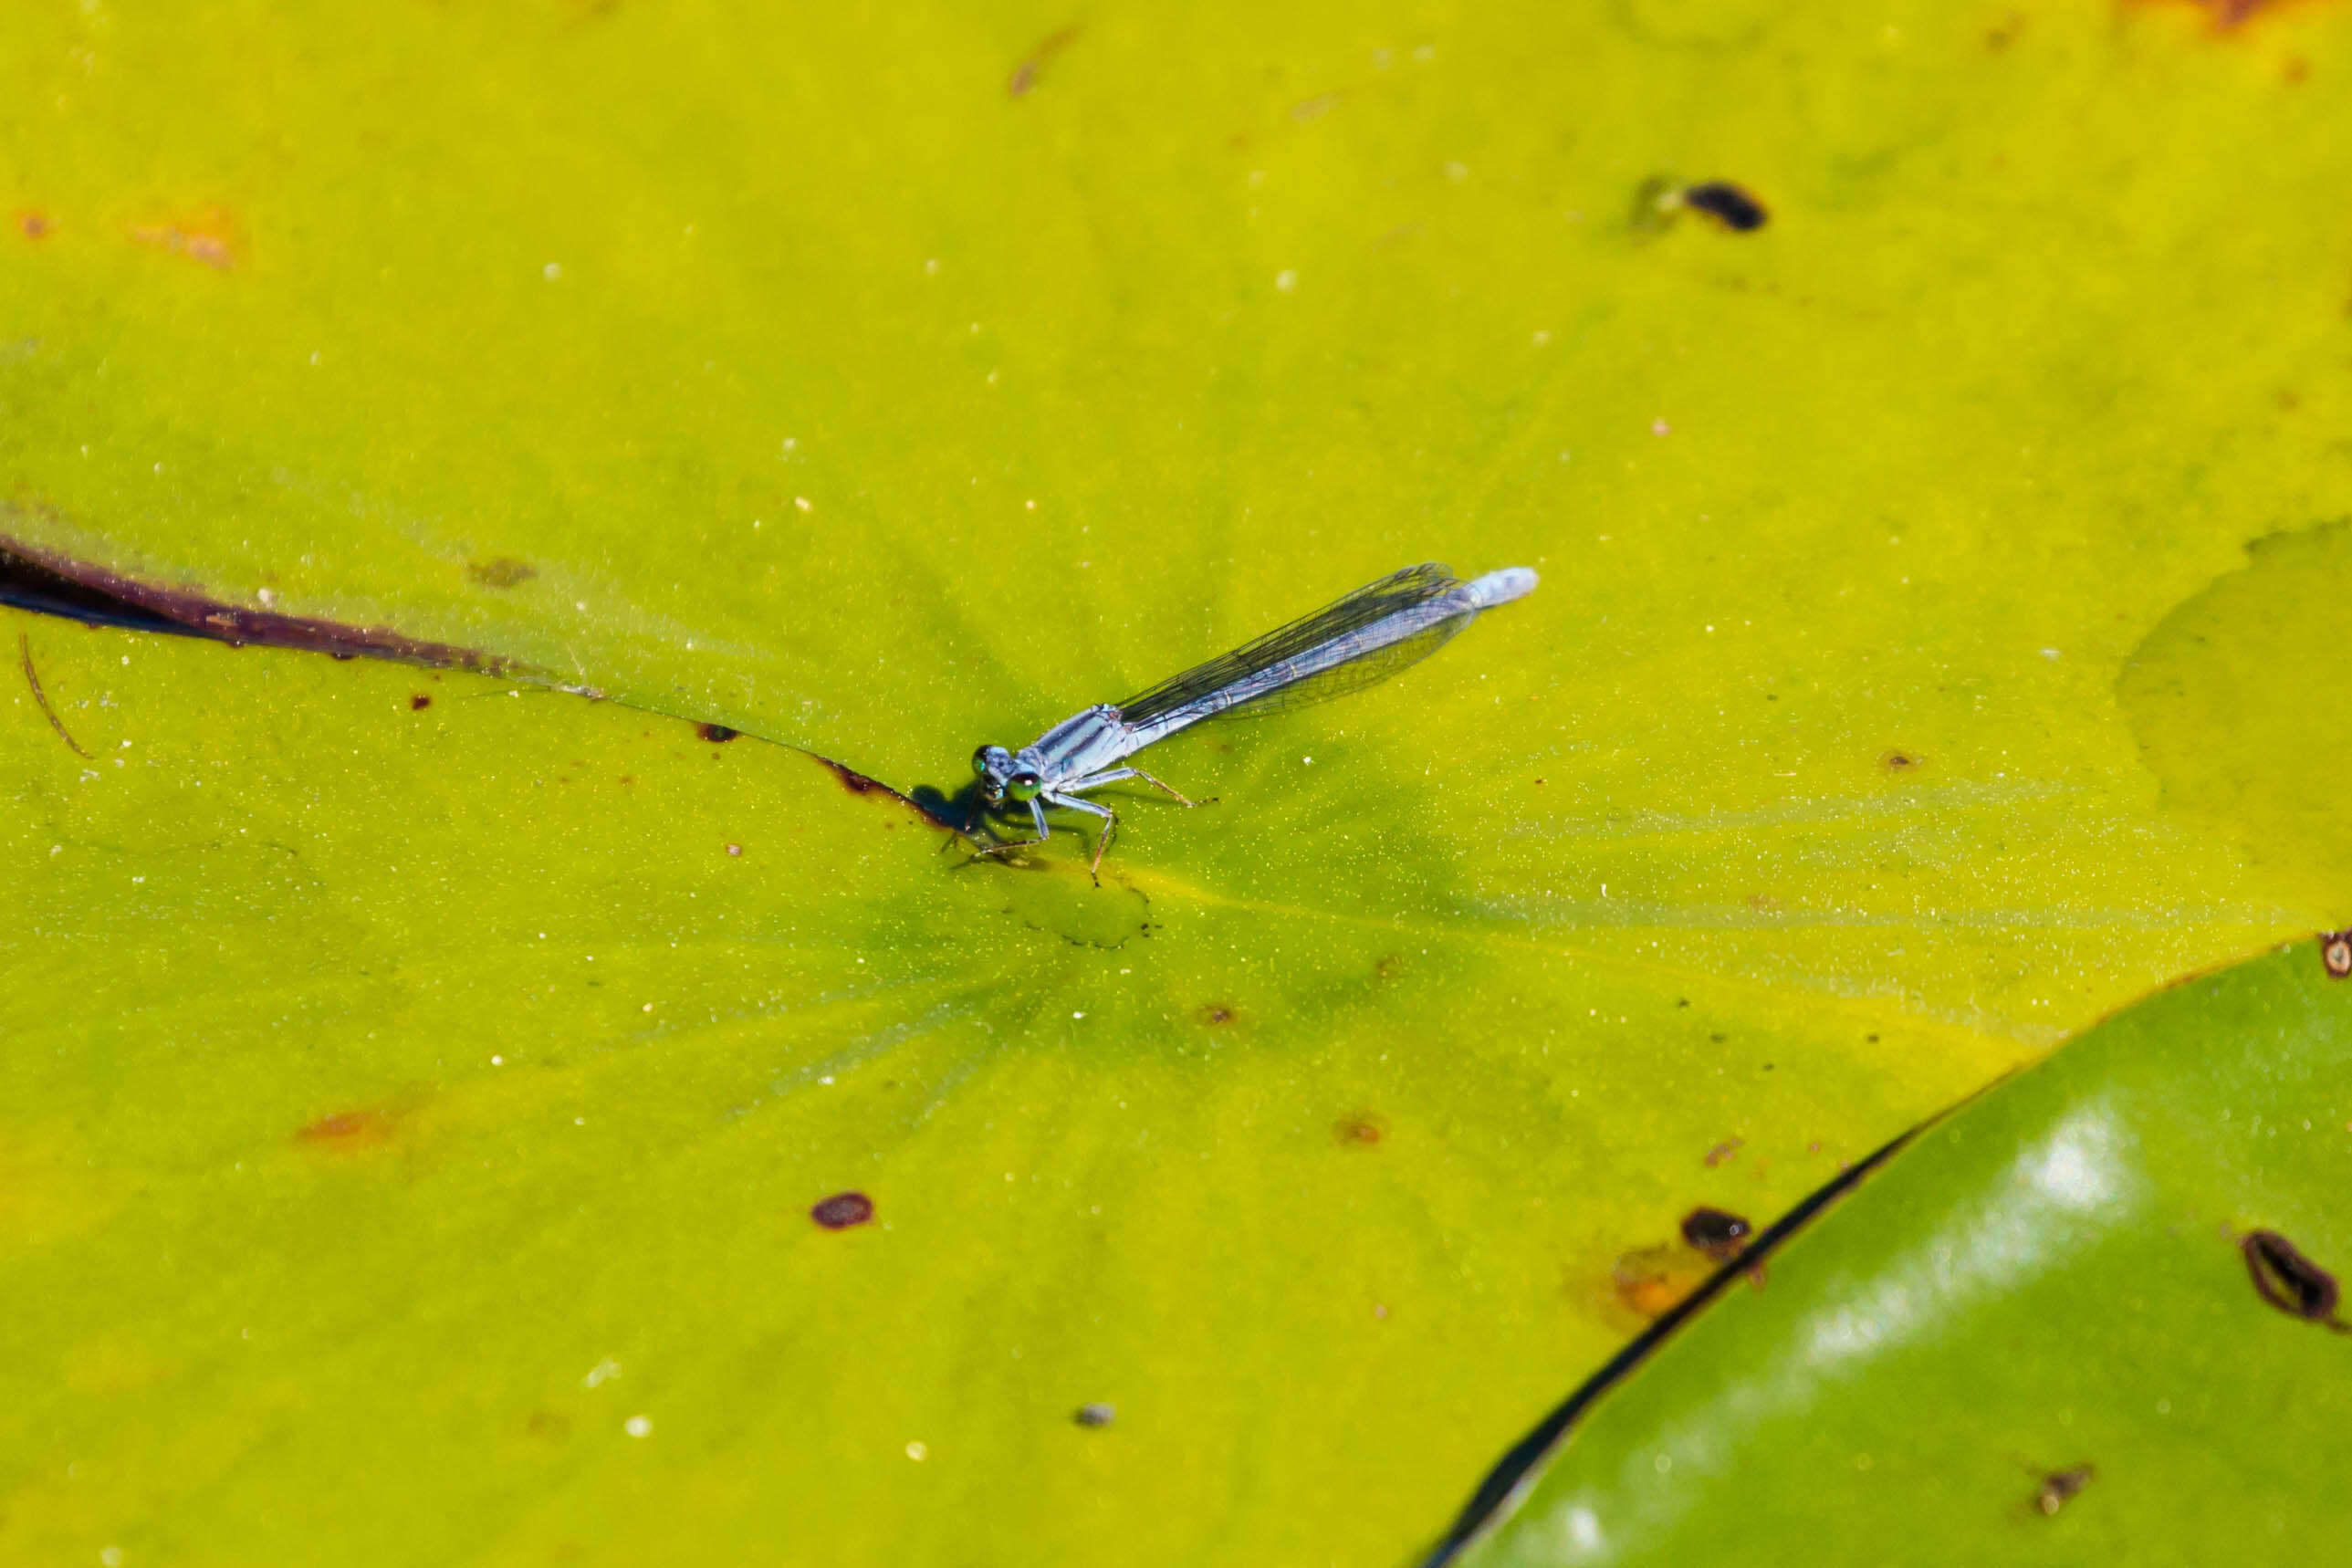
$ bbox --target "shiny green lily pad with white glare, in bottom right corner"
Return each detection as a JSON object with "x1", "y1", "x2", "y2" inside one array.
[{"x1": 1454, "y1": 943, "x2": 2352, "y2": 1568}]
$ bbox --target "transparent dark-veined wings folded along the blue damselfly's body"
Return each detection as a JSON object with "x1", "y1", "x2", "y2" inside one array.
[{"x1": 1120, "y1": 562, "x2": 1477, "y2": 727}]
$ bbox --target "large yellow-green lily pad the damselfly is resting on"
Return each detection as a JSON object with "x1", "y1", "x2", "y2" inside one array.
[{"x1": 0, "y1": 3, "x2": 2352, "y2": 1563}]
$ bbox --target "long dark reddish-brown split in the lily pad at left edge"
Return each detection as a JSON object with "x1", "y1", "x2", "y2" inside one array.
[{"x1": 0, "y1": 533, "x2": 537, "y2": 677}]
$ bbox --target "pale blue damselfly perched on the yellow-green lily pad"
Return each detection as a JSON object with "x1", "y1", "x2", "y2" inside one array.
[{"x1": 971, "y1": 562, "x2": 1536, "y2": 873}]
